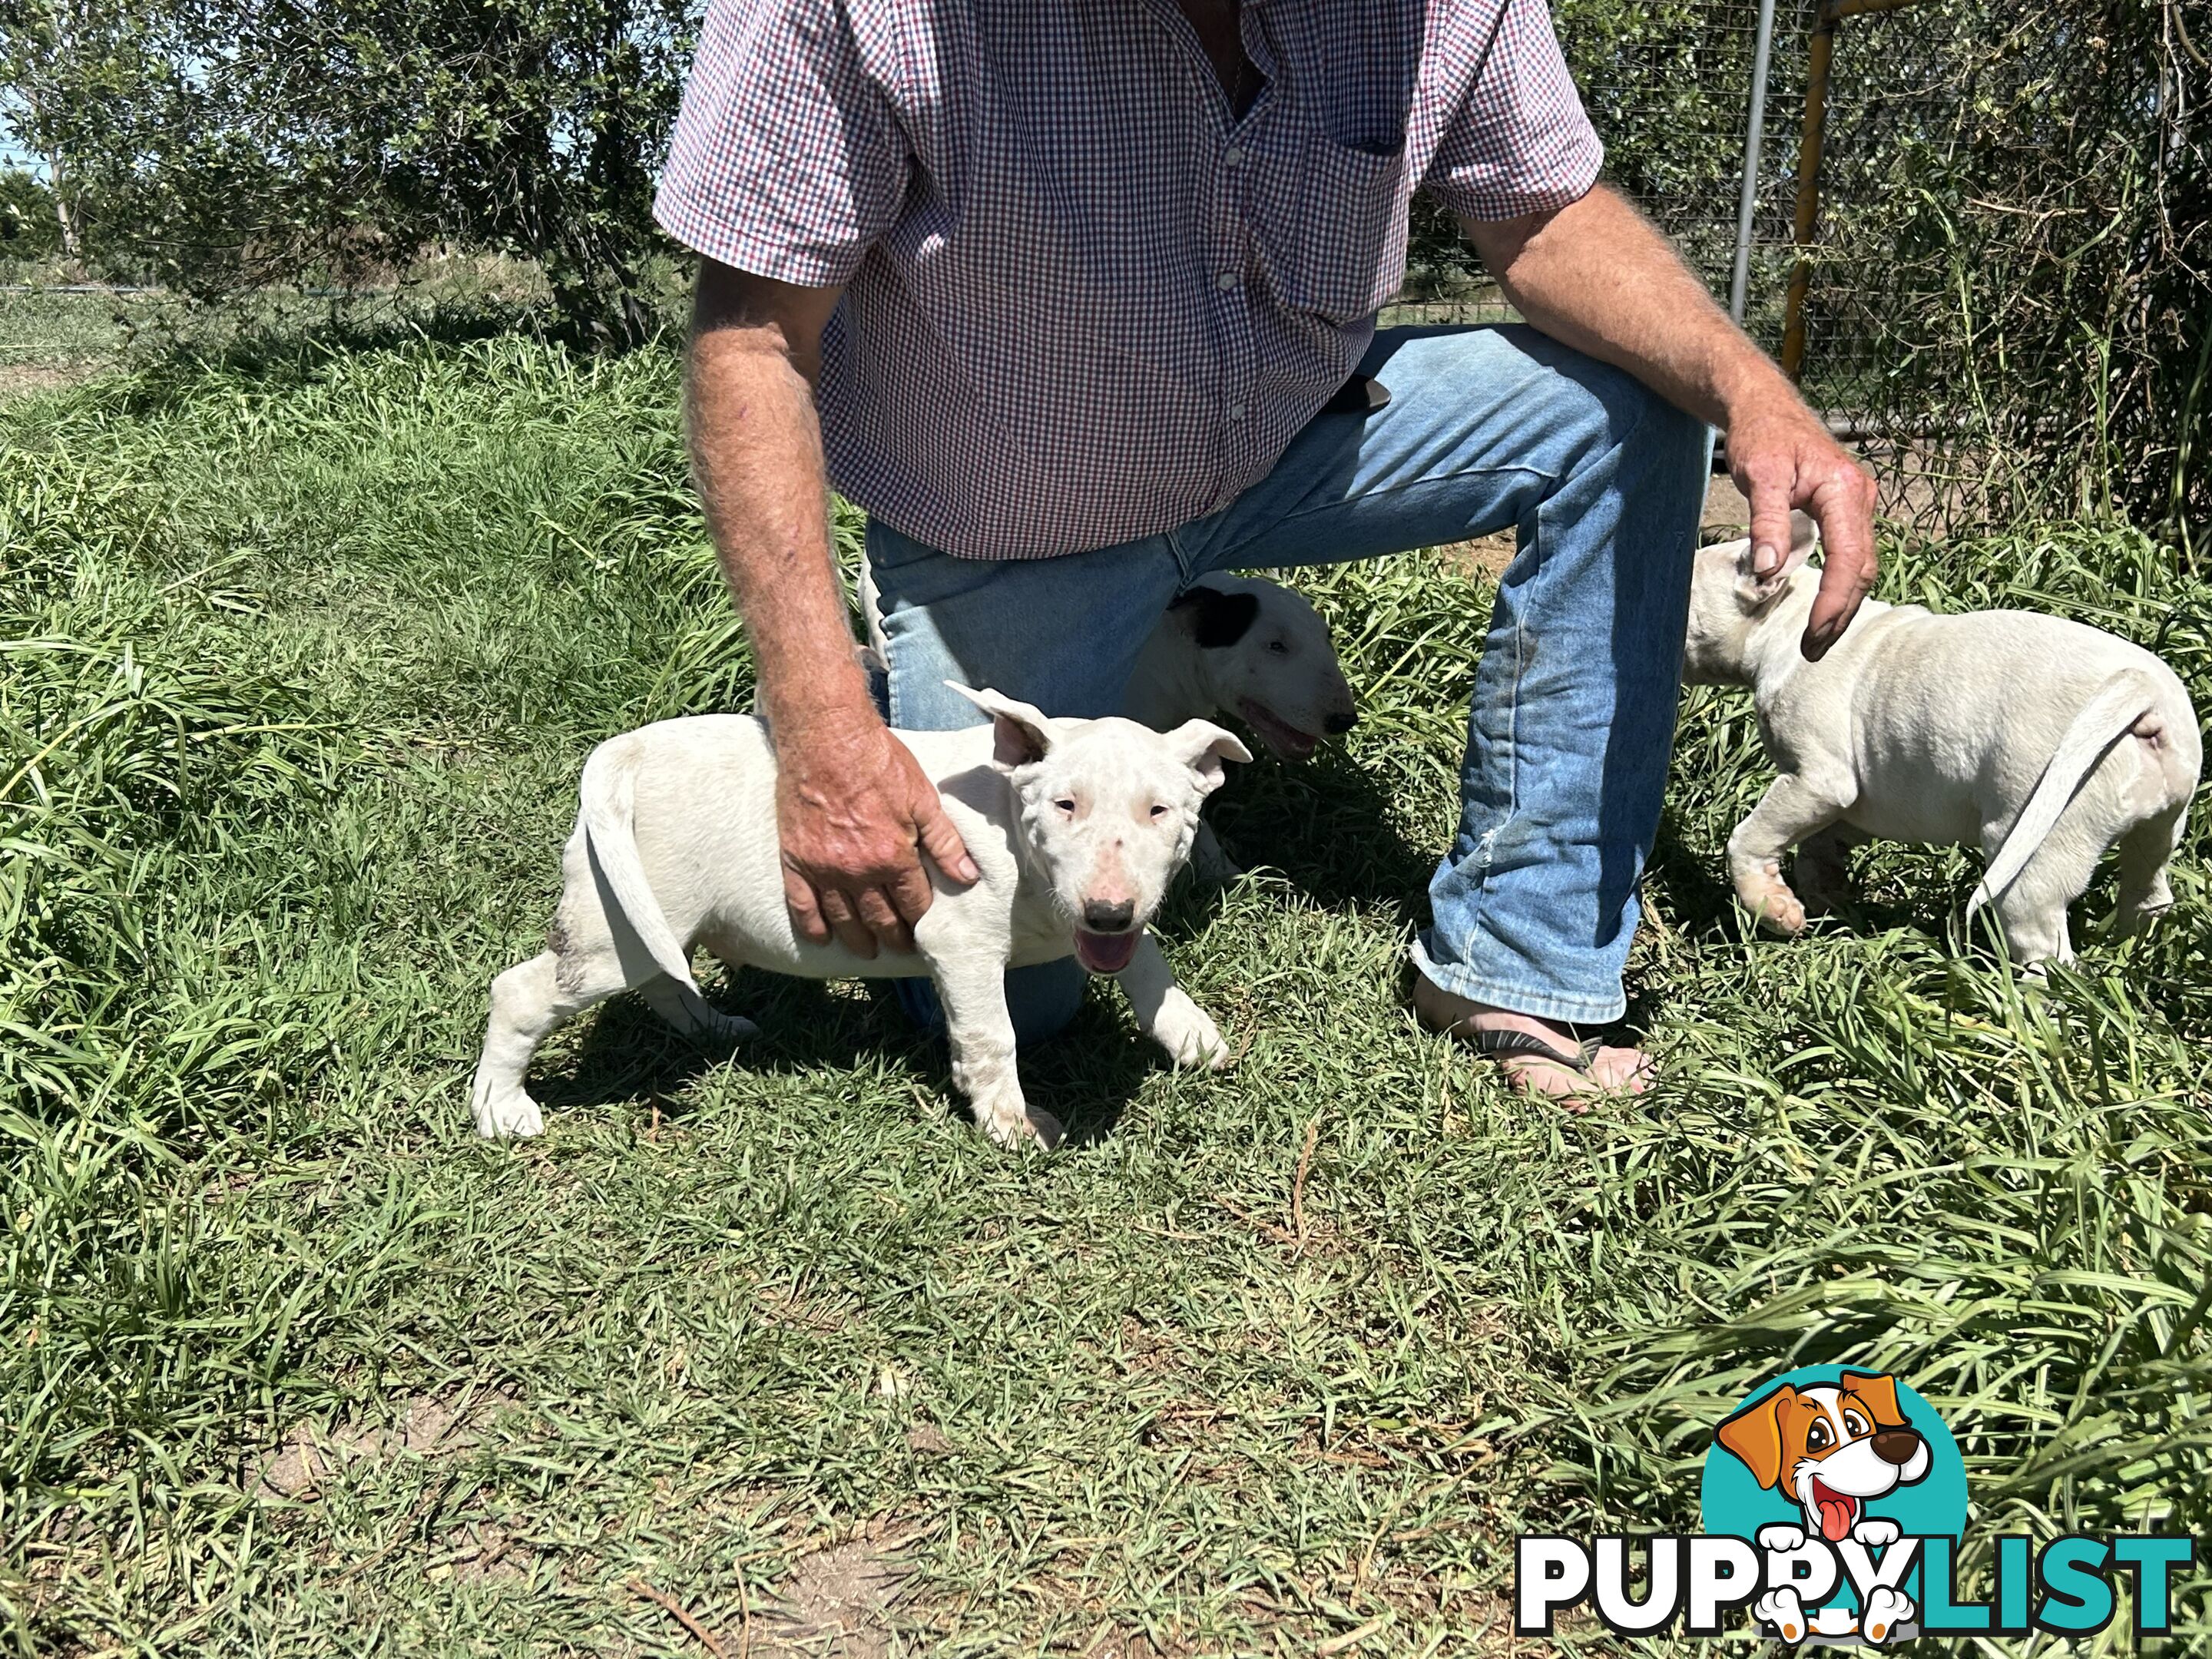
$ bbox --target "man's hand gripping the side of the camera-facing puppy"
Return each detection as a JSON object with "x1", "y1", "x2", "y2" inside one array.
[{"x1": 777, "y1": 714, "x2": 980, "y2": 958}]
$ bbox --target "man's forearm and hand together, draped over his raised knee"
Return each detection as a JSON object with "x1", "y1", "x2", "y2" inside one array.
[{"x1": 1460, "y1": 186, "x2": 1876, "y2": 659}]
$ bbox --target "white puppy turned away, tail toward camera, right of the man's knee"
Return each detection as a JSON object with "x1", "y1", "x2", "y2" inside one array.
[{"x1": 1684, "y1": 513, "x2": 2203, "y2": 967}]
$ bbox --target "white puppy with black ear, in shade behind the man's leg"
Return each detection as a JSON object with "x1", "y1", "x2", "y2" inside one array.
[{"x1": 1121, "y1": 575, "x2": 1360, "y2": 882}]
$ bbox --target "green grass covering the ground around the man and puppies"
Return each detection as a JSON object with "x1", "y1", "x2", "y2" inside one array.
[{"x1": 0, "y1": 339, "x2": 2212, "y2": 1654}]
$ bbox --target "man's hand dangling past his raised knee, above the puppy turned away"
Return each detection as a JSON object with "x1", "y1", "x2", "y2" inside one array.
[{"x1": 1727, "y1": 391, "x2": 1878, "y2": 661}]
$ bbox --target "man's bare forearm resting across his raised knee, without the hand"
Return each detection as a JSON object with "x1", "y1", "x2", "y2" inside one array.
[{"x1": 1465, "y1": 186, "x2": 1796, "y2": 427}]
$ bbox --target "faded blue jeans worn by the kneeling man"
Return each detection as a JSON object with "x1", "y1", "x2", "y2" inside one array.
[{"x1": 867, "y1": 325, "x2": 1712, "y2": 1040}]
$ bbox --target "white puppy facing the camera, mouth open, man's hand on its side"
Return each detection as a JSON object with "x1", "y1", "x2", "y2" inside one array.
[{"x1": 473, "y1": 686, "x2": 1252, "y2": 1146}]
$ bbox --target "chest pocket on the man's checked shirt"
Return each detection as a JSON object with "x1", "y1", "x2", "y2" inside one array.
[{"x1": 1277, "y1": 133, "x2": 1411, "y2": 325}]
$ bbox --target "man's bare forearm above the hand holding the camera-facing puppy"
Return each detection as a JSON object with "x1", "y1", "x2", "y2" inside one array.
[{"x1": 686, "y1": 310, "x2": 872, "y2": 734}]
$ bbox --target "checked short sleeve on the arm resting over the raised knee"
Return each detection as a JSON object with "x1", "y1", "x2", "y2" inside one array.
[{"x1": 1420, "y1": 0, "x2": 1606, "y2": 221}]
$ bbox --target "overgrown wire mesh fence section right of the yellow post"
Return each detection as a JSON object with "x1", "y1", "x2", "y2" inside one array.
[{"x1": 1805, "y1": 0, "x2": 2212, "y2": 535}]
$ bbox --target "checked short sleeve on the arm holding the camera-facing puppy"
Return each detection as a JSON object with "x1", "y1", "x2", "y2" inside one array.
[{"x1": 653, "y1": 0, "x2": 912, "y2": 287}]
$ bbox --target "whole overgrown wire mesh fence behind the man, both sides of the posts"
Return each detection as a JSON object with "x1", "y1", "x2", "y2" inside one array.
[{"x1": 1407, "y1": 0, "x2": 2212, "y2": 540}]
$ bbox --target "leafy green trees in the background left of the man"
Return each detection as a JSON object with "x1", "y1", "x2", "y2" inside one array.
[{"x1": 0, "y1": 0, "x2": 697, "y2": 343}]
